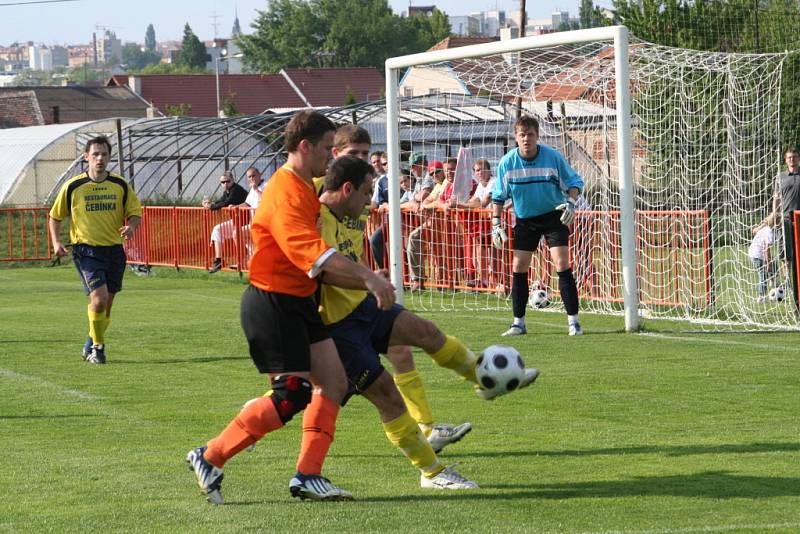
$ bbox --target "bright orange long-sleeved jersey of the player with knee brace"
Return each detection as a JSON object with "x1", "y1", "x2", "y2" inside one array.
[{"x1": 250, "y1": 165, "x2": 335, "y2": 297}]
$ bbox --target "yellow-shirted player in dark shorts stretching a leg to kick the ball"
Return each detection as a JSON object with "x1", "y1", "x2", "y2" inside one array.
[{"x1": 320, "y1": 156, "x2": 478, "y2": 489}]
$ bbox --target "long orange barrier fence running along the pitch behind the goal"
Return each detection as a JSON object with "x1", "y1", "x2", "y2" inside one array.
[{"x1": 0, "y1": 206, "x2": 720, "y2": 307}]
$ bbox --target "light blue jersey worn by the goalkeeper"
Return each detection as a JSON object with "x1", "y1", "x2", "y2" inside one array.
[{"x1": 492, "y1": 143, "x2": 583, "y2": 219}]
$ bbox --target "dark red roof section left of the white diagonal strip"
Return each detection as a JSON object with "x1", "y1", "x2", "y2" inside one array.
[{"x1": 108, "y1": 74, "x2": 305, "y2": 117}]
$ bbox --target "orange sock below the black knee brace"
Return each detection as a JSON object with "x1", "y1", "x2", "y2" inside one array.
[{"x1": 203, "y1": 397, "x2": 282, "y2": 468}]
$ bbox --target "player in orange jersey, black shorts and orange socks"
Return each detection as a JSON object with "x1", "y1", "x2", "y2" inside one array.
[{"x1": 186, "y1": 110, "x2": 394, "y2": 504}]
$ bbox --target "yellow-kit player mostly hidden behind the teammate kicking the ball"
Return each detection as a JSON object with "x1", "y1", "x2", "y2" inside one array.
[{"x1": 326, "y1": 124, "x2": 472, "y2": 452}]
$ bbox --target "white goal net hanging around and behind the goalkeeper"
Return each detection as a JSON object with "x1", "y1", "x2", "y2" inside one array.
[{"x1": 376, "y1": 28, "x2": 800, "y2": 336}]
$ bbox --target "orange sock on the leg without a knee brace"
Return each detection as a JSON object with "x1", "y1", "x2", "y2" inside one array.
[{"x1": 297, "y1": 393, "x2": 339, "y2": 475}]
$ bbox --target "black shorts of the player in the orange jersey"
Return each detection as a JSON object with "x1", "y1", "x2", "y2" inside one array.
[{"x1": 240, "y1": 285, "x2": 330, "y2": 373}]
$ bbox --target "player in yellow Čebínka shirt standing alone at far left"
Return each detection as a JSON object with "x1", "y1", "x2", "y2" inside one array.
[{"x1": 49, "y1": 136, "x2": 142, "y2": 364}]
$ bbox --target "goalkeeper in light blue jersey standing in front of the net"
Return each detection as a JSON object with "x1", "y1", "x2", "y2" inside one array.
[{"x1": 492, "y1": 115, "x2": 583, "y2": 336}]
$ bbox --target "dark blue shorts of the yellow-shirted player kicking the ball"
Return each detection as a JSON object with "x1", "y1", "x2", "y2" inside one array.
[{"x1": 328, "y1": 294, "x2": 405, "y2": 406}]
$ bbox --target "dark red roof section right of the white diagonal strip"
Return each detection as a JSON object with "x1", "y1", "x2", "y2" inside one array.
[{"x1": 284, "y1": 67, "x2": 386, "y2": 106}]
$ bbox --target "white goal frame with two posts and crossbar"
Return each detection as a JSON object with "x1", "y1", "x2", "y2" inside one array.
[{"x1": 386, "y1": 26, "x2": 639, "y2": 331}]
